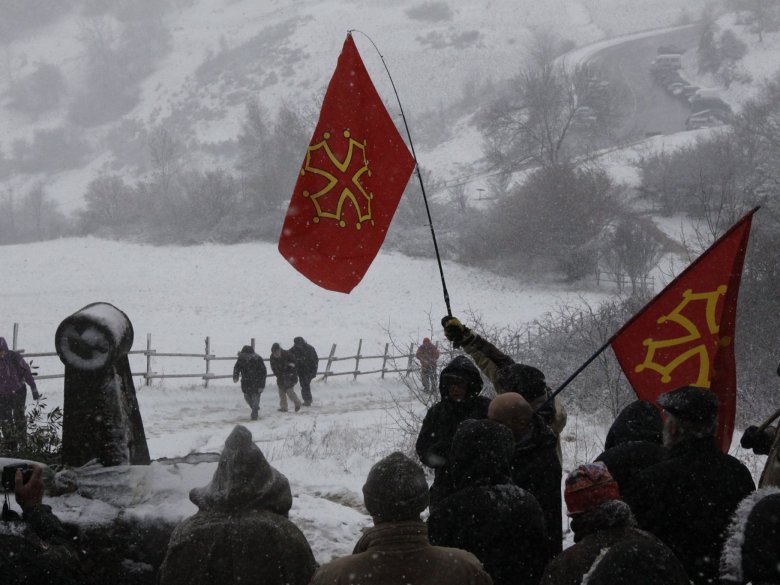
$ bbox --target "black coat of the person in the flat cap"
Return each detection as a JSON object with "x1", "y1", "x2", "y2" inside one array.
[{"x1": 623, "y1": 437, "x2": 755, "y2": 585}]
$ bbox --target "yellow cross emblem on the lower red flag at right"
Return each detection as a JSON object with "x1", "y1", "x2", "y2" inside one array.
[{"x1": 634, "y1": 285, "x2": 731, "y2": 388}]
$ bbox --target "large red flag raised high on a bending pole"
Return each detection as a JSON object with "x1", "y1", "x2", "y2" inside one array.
[{"x1": 279, "y1": 34, "x2": 414, "y2": 293}]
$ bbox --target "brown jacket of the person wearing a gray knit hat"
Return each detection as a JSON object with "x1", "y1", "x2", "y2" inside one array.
[{"x1": 311, "y1": 520, "x2": 492, "y2": 585}]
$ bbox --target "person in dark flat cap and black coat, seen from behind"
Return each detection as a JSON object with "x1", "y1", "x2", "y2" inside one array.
[{"x1": 624, "y1": 386, "x2": 755, "y2": 585}]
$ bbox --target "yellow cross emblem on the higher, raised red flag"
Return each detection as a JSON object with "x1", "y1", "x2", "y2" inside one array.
[{"x1": 301, "y1": 130, "x2": 374, "y2": 230}]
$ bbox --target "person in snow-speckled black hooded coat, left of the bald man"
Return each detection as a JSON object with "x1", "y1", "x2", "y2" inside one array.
[{"x1": 428, "y1": 420, "x2": 550, "y2": 585}]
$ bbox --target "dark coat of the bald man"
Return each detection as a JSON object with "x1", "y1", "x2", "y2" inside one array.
[{"x1": 512, "y1": 415, "x2": 563, "y2": 556}]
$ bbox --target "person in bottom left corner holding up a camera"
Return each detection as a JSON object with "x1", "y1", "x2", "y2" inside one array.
[{"x1": 0, "y1": 465, "x2": 85, "y2": 585}]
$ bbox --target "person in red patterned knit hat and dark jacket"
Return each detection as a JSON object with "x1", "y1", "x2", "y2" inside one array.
[{"x1": 542, "y1": 463, "x2": 689, "y2": 585}]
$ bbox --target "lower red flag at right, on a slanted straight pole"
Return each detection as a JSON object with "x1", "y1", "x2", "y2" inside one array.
[{"x1": 612, "y1": 208, "x2": 757, "y2": 452}]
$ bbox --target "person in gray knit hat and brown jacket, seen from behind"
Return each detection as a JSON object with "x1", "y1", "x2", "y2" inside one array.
[{"x1": 311, "y1": 452, "x2": 492, "y2": 585}]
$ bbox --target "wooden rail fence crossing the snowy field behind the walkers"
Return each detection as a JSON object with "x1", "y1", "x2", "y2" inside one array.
[{"x1": 11, "y1": 323, "x2": 454, "y2": 387}]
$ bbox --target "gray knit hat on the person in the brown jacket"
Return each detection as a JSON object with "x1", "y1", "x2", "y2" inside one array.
[{"x1": 363, "y1": 451, "x2": 428, "y2": 522}]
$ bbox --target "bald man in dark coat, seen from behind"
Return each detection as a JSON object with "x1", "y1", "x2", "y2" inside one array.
[{"x1": 488, "y1": 392, "x2": 563, "y2": 556}]
